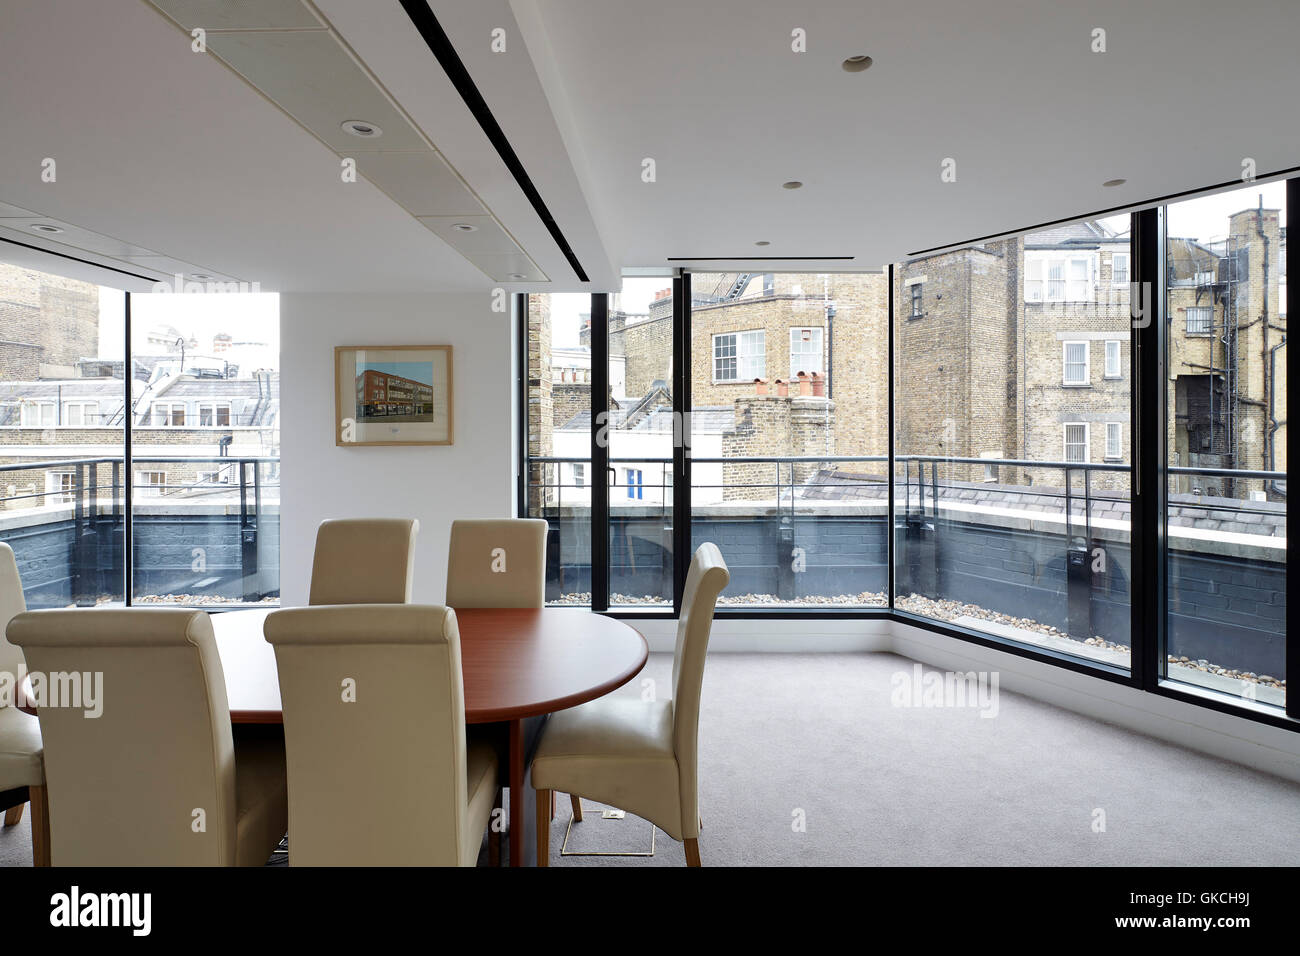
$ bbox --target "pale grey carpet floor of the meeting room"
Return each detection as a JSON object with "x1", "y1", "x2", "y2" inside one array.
[{"x1": 0, "y1": 654, "x2": 1300, "y2": 866}]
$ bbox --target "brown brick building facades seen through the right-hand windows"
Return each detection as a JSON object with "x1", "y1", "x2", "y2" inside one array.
[{"x1": 529, "y1": 209, "x2": 1286, "y2": 509}]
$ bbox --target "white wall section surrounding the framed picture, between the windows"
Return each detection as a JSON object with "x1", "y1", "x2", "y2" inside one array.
[{"x1": 280, "y1": 291, "x2": 515, "y2": 607}]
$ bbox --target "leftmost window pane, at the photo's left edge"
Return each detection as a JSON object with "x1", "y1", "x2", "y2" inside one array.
[{"x1": 0, "y1": 263, "x2": 126, "y2": 607}]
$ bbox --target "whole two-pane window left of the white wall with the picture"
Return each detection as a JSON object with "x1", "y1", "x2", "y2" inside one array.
[{"x1": 0, "y1": 257, "x2": 280, "y2": 607}]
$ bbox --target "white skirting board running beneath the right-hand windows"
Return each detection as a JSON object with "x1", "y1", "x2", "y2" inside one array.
[{"x1": 650, "y1": 619, "x2": 1300, "y2": 782}]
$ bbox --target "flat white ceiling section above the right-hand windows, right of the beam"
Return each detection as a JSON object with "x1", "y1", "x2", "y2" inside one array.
[{"x1": 514, "y1": 0, "x2": 1300, "y2": 268}]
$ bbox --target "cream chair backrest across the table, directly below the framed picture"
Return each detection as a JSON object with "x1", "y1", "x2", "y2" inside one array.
[{"x1": 307, "y1": 518, "x2": 420, "y2": 605}]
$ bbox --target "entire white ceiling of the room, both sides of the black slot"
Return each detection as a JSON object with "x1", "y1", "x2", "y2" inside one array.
[{"x1": 0, "y1": 0, "x2": 1300, "y2": 291}]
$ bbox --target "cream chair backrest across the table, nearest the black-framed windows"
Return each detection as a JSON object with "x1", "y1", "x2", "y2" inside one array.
[{"x1": 447, "y1": 518, "x2": 547, "y2": 607}]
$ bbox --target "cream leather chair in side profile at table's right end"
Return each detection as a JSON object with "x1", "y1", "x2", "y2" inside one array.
[{"x1": 533, "y1": 544, "x2": 731, "y2": 866}]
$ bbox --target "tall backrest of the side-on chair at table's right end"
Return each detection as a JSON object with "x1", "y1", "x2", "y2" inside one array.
[{"x1": 672, "y1": 542, "x2": 731, "y2": 838}]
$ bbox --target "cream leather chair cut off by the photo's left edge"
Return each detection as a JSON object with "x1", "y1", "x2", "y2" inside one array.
[{"x1": 0, "y1": 542, "x2": 49, "y2": 866}]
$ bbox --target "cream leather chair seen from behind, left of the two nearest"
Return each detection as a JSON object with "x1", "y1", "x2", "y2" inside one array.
[{"x1": 9, "y1": 607, "x2": 289, "y2": 866}]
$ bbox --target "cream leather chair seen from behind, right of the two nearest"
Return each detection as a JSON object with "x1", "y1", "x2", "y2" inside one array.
[{"x1": 265, "y1": 605, "x2": 497, "y2": 866}]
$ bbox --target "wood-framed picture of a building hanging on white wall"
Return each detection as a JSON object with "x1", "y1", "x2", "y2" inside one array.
[{"x1": 334, "y1": 345, "x2": 452, "y2": 445}]
